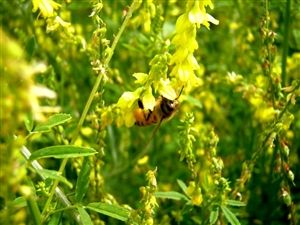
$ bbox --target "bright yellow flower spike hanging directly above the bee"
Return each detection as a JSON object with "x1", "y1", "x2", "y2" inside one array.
[{"x1": 170, "y1": 0, "x2": 219, "y2": 86}]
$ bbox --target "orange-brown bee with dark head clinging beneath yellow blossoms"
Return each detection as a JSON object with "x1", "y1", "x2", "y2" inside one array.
[{"x1": 134, "y1": 89, "x2": 182, "y2": 126}]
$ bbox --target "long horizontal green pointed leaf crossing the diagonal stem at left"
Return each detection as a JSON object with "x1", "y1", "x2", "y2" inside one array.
[{"x1": 29, "y1": 145, "x2": 97, "y2": 160}]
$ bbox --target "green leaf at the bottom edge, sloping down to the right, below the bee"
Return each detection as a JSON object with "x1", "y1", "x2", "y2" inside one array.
[{"x1": 86, "y1": 202, "x2": 130, "y2": 221}]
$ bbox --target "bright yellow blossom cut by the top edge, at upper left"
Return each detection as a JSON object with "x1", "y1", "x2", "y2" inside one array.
[{"x1": 32, "y1": 0, "x2": 60, "y2": 18}]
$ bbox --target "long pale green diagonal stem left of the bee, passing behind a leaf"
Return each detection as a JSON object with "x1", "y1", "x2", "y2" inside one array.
[{"x1": 42, "y1": 0, "x2": 137, "y2": 221}]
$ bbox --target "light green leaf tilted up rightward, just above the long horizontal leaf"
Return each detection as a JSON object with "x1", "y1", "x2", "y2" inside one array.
[{"x1": 34, "y1": 113, "x2": 72, "y2": 132}]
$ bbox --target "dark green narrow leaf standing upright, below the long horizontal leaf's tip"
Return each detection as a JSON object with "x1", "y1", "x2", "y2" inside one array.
[{"x1": 75, "y1": 158, "x2": 91, "y2": 202}]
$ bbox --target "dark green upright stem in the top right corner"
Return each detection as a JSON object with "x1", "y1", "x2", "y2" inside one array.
[{"x1": 281, "y1": 0, "x2": 291, "y2": 87}]
